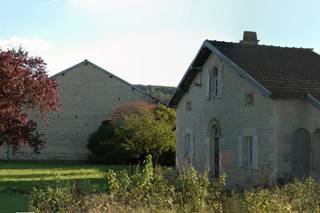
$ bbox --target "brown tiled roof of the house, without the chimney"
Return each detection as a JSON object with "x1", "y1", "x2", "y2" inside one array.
[{"x1": 170, "y1": 40, "x2": 320, "y2": 106}]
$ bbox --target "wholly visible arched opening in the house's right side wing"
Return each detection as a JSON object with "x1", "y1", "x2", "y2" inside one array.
[{"x1": 292, "y1": 129, "x2": 311, "y2": 178}]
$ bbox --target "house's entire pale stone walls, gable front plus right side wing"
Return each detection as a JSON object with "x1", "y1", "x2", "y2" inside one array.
[{"x1": 176, "y1": 53, "x2": 320, "y2": 187}]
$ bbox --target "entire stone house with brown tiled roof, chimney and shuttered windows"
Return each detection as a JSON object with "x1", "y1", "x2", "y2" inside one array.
[{"x1": 169, "y1": 32, "x2": 320, "y2": 186}]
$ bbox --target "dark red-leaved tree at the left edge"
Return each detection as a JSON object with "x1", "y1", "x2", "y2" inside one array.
[{"x1": 0, "y1": 48, "x2": 59, "y2": 153}]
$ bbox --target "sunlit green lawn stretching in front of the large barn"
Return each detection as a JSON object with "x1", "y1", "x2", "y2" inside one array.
[{"x1": 0, "y1": 161, "x2": 125, "y2": 213}]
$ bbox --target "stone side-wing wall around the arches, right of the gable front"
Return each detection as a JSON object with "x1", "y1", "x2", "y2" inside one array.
[{"x1": 273, "y1": 100, "x2": 320, "y2": 178}]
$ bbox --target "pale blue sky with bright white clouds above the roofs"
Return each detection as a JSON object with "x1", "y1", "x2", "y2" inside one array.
[{"x1": 0, "y1": 0, "x2": 320, "y2": 86}]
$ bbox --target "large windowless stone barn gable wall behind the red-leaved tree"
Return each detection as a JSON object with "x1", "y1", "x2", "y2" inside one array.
[{"x1": 0, "y1": 60, "x2": 158, "y2": 161}]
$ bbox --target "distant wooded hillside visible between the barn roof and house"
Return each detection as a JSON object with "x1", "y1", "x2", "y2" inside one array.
[{"x1": 135, "y1": 84, "x2": 176, "y2": 104}]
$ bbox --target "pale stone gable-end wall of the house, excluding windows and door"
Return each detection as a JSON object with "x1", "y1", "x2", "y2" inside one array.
[{"x1": 176, "y1": 54, "x2": 276, "y2": 186}]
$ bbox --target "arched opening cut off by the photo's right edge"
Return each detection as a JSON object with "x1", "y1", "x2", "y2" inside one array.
[{"x1": 311, "y1": 129, "x2": 320, "y2": 178}]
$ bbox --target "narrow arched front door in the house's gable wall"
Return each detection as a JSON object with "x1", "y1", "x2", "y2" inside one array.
[{"x1": 208, "y1": 120, "x2": 221, "y2": 178}]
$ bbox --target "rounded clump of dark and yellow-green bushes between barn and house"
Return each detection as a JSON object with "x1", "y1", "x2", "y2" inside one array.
[{"x1": 88, "y1": 102, "x2": 175, "y2": 165}]
